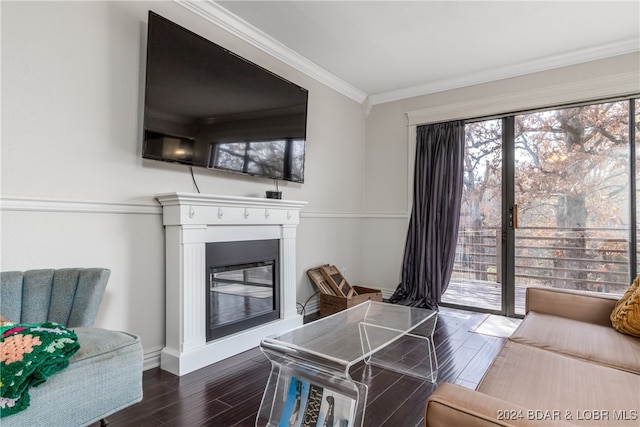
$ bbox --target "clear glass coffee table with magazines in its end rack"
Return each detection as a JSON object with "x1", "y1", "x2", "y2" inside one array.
[{"x1": 256, "y1": 301, "x2": 438, "y2": 427}]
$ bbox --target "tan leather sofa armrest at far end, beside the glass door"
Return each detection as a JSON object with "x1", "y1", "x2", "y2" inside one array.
[{"x1": 526, "y1": 287, "x2": 619, "y2": 326}]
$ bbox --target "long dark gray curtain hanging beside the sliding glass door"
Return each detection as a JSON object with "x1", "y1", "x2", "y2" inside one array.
[{"x1": 389, "y1": 121, "x2": 464, "y2": 309}]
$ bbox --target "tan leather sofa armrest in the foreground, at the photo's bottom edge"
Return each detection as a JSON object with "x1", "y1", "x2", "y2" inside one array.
[{"x1": 424, "y1": 383, "x2": 573, "y2": 427}]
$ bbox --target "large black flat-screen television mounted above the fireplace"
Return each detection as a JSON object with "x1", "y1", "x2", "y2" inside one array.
[{"x1": 142, "y1": 11, "x2": 308, "y2": 182}]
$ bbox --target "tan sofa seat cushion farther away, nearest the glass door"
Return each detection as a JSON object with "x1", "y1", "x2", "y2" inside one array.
[{"x1": 509, "y1": 311, "x2": 640, "y2": 374}]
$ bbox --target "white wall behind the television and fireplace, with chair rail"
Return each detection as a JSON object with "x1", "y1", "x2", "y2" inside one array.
[{"x1": 0, "y1": 1, "x2": 365, "y2": 368}]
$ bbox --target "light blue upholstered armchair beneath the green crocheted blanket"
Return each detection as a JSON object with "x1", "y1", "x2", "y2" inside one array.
[{"x1": 0, "y1": 268, "x2": 143, "y2": 427}]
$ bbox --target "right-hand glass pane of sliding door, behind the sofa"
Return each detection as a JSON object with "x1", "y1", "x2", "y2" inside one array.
[{"x1": 515, "y1": 101, "x2": 630, "y2": 314}]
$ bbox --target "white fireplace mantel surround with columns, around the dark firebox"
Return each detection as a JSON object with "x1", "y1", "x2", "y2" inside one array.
[{"x1": 156, "y1": 193, "x2": 306, "y2": 375}]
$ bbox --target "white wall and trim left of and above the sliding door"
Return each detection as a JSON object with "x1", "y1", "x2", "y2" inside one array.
[{"x1": 362, "y1": 54, "x2": 640, "y2": 294}]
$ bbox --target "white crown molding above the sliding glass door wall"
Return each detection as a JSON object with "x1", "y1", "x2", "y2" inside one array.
[{"x1": 369, "y1": 39, "x2": 640, "y2": 105}]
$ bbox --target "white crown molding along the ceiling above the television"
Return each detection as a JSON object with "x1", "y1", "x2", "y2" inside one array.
[{"x1": 174, "y1": 0, "x2": 367, "y2": 104}]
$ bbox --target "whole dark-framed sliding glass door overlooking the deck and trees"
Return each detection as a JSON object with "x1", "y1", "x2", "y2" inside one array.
[{"x1": 442, "y1": 100, "x2": 640, "y2": 315}]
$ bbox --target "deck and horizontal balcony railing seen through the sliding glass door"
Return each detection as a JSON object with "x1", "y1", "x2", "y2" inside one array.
[{"x1": 443, "y1": 227, "x2": 629, "y2": 311}]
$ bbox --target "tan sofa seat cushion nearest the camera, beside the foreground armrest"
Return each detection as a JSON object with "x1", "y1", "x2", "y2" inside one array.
[{"x1": 478, "y1": 341, "x2": 640, "y2": 427}]
